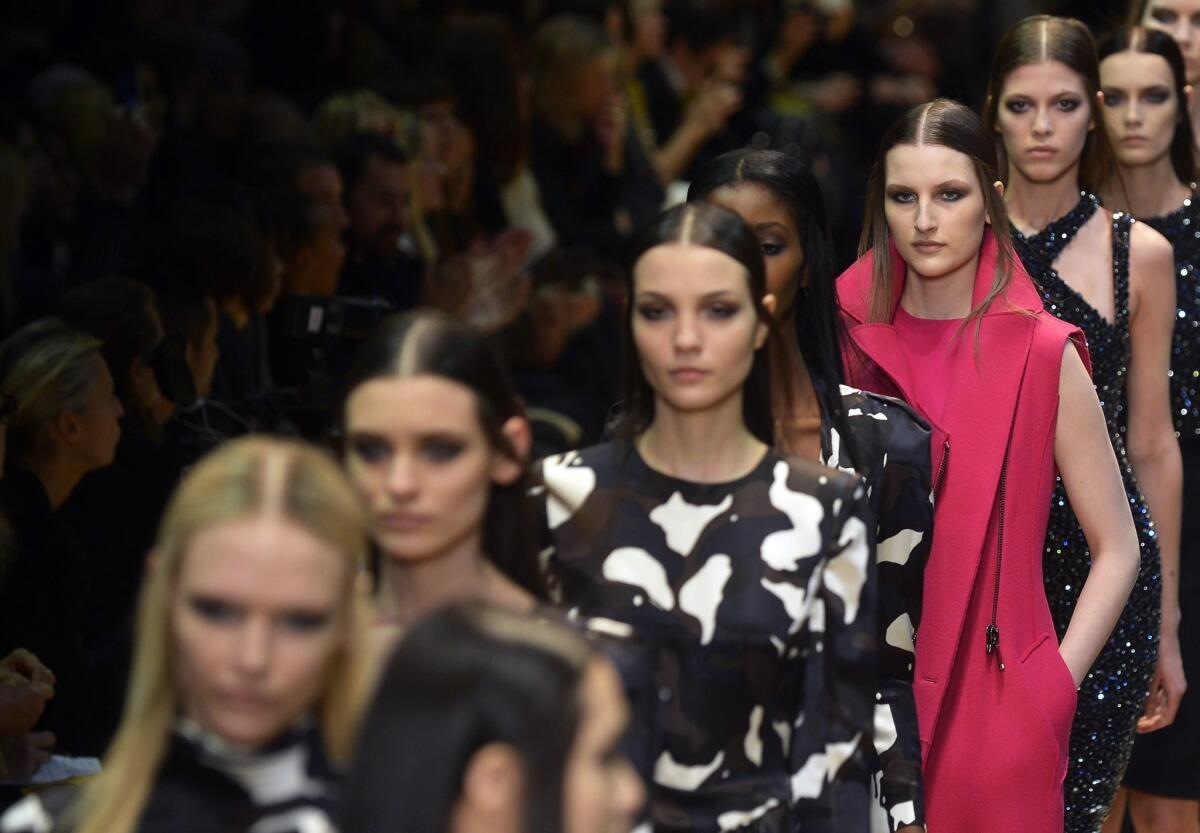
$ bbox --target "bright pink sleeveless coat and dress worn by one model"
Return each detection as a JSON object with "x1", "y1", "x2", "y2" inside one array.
[{"x1": 838, "y1": 229, "x2": 1086, "y2": 833}]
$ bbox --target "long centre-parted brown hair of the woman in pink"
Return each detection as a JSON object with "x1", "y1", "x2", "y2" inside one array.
[{"x1": 858, "y1": 98, "x2": 1016, "y2": 322}]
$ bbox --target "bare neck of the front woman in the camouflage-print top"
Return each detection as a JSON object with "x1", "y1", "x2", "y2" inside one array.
[{"x1": 637, "y1": 390, "x2": 767, "y2": 483}]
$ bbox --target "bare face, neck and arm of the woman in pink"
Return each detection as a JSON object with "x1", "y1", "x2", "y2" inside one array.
[{"x1": 886, "y1": 144, "x2": 1138, "y2": 685}]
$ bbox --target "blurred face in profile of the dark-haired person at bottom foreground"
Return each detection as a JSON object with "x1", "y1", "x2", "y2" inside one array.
[{"x1": 563, "y1": 659, "x2": 646, "y2": 833}]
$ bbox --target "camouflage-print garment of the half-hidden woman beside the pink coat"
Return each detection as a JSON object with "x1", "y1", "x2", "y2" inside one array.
[{"x1": 821, "y1": 385, "x2": 934, "y2": 832}]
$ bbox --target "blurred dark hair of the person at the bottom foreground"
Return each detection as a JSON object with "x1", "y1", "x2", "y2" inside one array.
[{"x1": 338, "y1": 606, "x2": 593, "y2": 833}]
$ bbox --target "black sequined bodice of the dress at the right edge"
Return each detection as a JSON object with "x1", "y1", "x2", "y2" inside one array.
[{"x1": 1144, "y1": 198, "x2": 1200, "y2": 438}]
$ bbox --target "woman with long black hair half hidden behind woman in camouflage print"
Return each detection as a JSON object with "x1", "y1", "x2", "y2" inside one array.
[{"x1": 688, "y1": 149, "x2": 934, "y2": 833}]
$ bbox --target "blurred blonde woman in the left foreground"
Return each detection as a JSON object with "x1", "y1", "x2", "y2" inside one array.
[{"x1": 0, "y1": 437, "x2": 367, "y2": 833}]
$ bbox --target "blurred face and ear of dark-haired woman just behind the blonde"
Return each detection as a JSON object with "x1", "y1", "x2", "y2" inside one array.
[{"x1": 346, "y1": 374, "x2": 521, "y2": 562}]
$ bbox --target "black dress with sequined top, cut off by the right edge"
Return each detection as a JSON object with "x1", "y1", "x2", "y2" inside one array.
[{"x1": 1126, "y1": 197, "x2": 1200, "y2": 801}]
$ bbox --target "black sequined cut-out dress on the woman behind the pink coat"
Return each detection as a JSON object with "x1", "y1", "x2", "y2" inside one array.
[{"x1": 1014, "y1": 193, "x2": 1160, "y2": 833}]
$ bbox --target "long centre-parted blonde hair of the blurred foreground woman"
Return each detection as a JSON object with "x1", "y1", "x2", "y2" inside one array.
[{"x1": 71, "y1": 437, "x2": 372, "y2": 833}]
